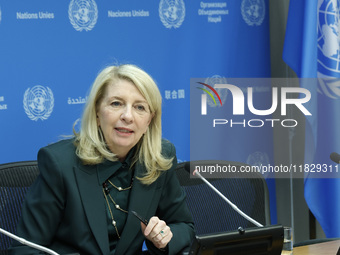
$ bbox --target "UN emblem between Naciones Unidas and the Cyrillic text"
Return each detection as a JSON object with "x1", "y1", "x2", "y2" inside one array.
[{"x1": 158, "y1": 0, "x2": 185, "y2": 29}]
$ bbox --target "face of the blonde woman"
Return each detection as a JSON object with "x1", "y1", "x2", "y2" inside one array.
[{"x1": 97, "y1": 80, "x2": 152, "y2": 160}]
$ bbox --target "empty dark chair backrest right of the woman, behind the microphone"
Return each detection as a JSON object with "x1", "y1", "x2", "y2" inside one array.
[{"x1": 176, "y1": 160, "x2": 270, "y2": 235}]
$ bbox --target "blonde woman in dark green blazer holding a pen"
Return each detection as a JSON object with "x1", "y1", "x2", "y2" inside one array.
[{"x1": 10, "y1": 65, "x2": 194, "y2": 255}]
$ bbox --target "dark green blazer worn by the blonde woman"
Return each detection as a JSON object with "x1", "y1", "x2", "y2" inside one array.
[{"x1": 10, "y1": 139, "x2": 194, "y2": 255}]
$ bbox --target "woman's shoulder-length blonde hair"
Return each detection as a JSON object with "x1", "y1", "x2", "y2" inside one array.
[{"x1": 75, "y1": 64, "x2": 173, "y2": 184}]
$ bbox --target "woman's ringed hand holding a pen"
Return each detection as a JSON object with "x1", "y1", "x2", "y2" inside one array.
[{"x1": 141, "y1": 216, "x2": 173, "y2": 249}]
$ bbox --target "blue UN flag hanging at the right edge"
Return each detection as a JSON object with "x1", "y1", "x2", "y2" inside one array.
[{"x1": 283, "y1": 0, "x2": 340, "y2": 237}]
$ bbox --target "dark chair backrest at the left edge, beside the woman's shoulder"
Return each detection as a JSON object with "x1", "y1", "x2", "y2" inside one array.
[{"x1": 0, "y1": 161, "x2": 39, "y2": 255}]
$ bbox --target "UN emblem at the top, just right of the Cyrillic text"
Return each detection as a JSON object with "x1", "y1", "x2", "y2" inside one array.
[{"x1": 241, "y1": 0, "x2": 266, "y2": 26}]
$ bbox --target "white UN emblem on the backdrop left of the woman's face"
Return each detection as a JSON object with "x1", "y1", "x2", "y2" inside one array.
[{"x1": 23, "y1": 85, "x2": 54, "y2": 121}]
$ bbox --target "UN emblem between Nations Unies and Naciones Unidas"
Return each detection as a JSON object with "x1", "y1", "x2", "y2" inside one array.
[{"x1": 68, "y1": 0, "x2": 98, "y2": 32}]
